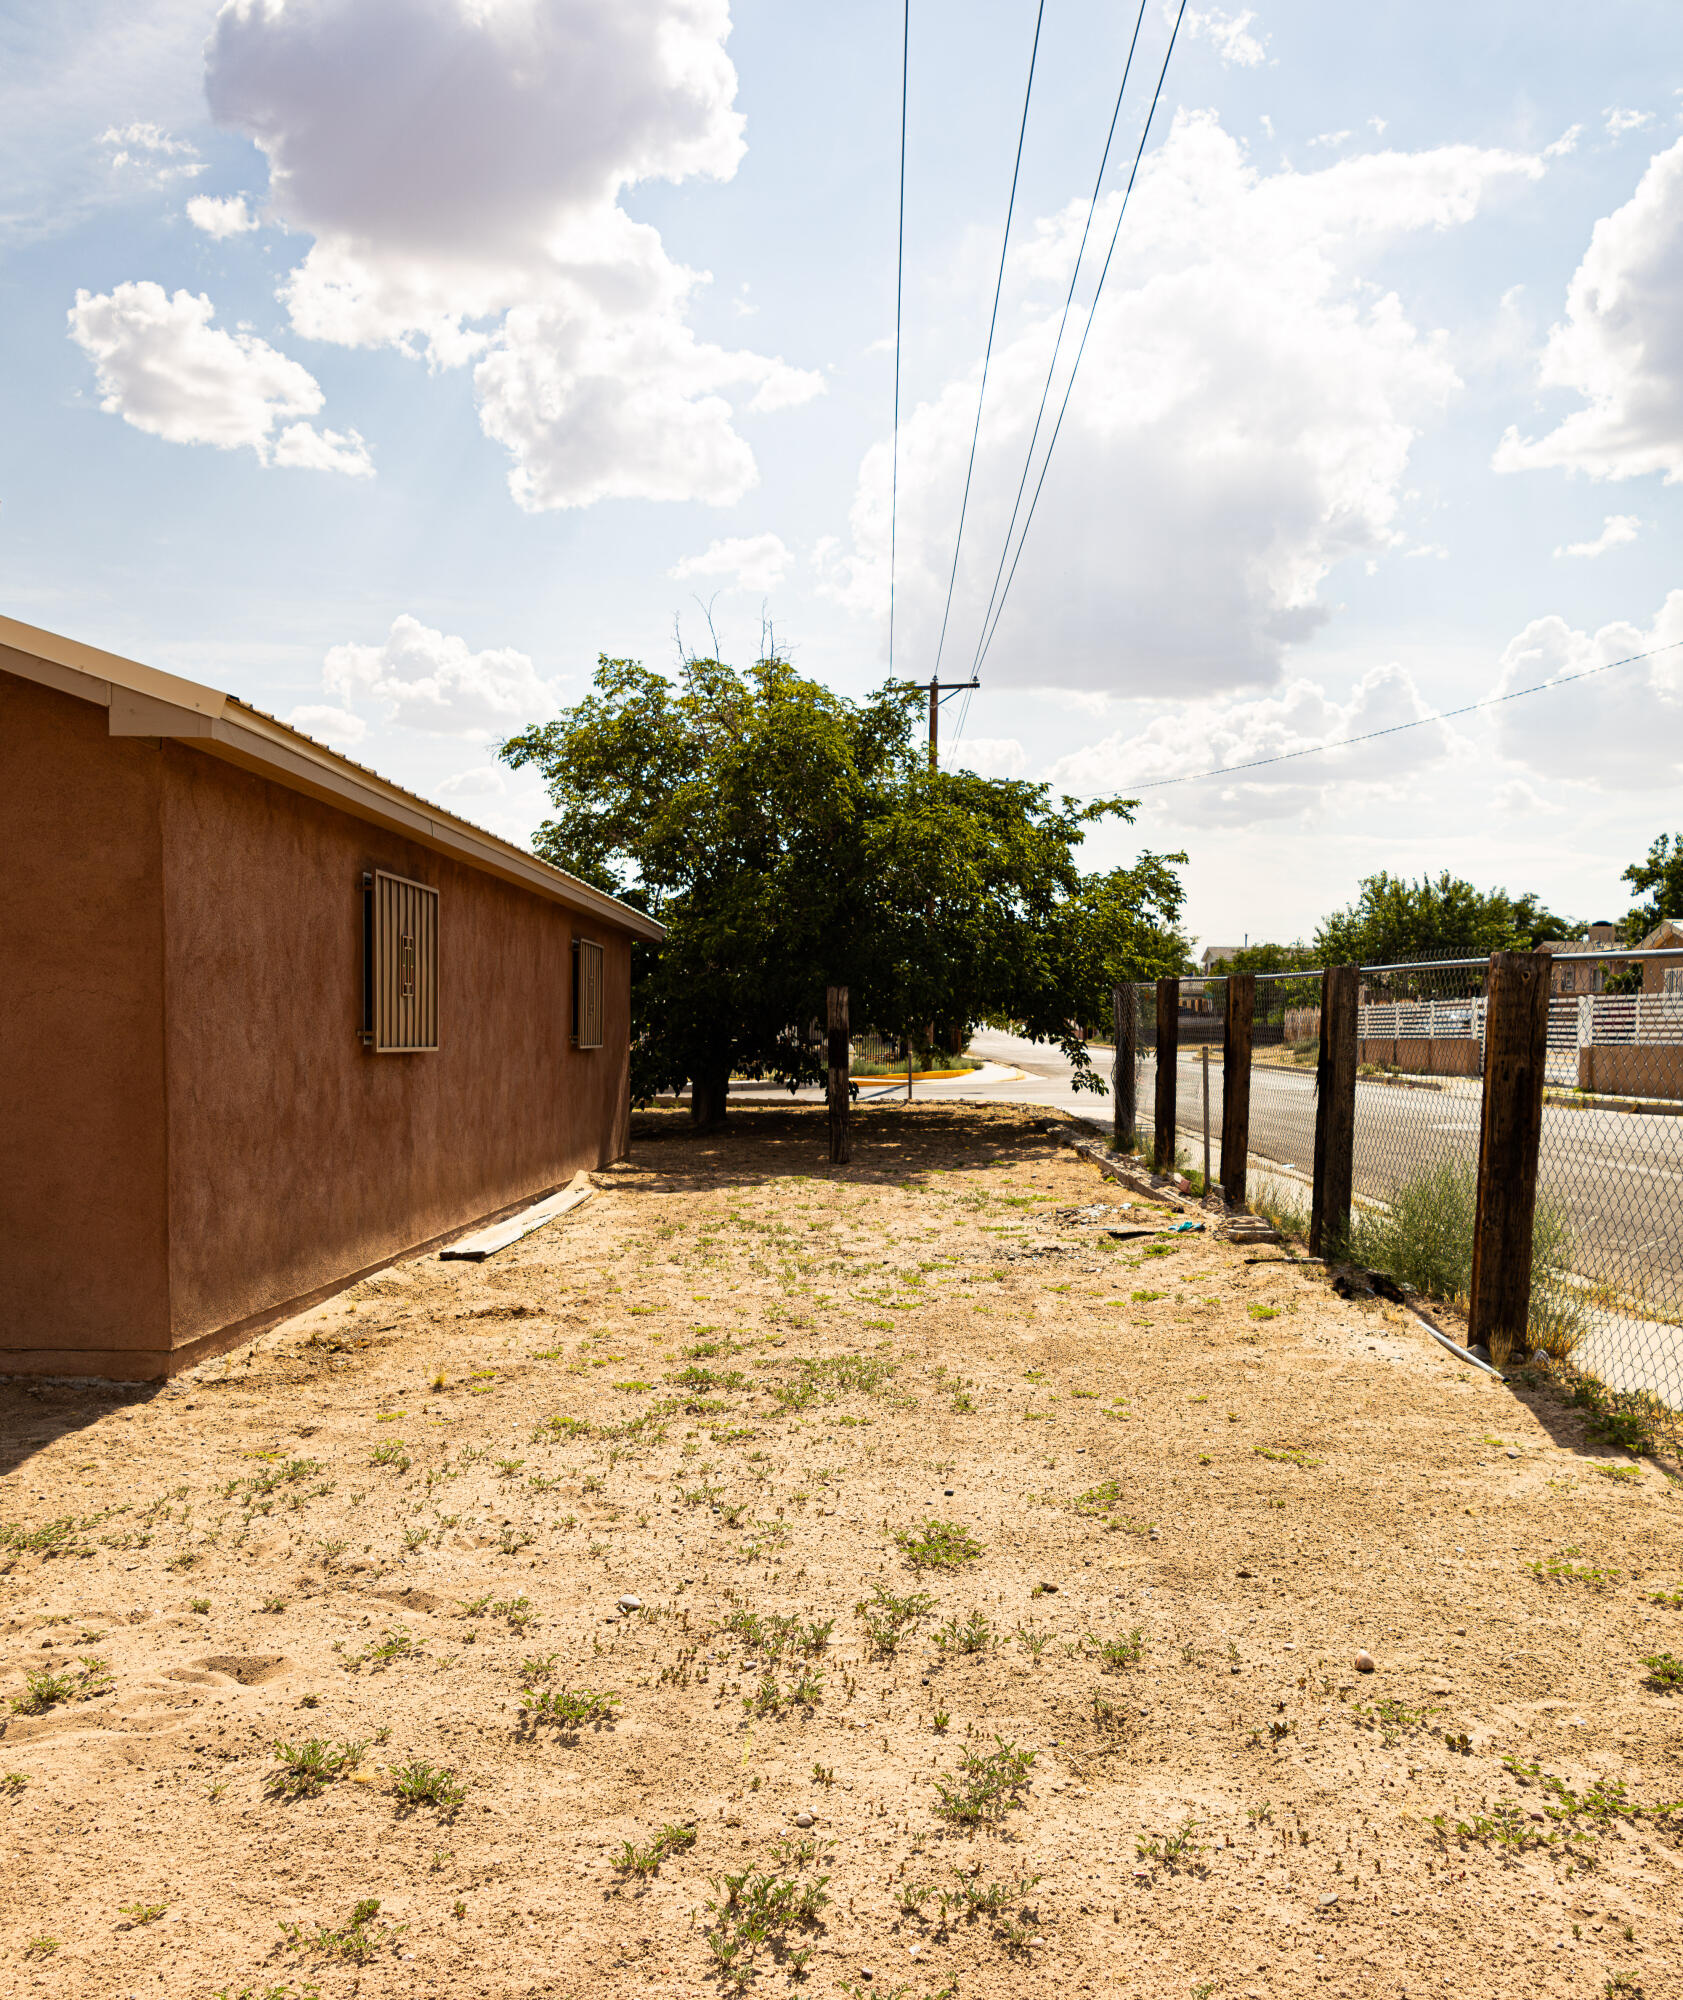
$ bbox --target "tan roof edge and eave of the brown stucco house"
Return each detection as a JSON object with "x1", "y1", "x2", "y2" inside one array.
[{"x1": 0, "y1": 616, "x2": 666, "y2": 942}]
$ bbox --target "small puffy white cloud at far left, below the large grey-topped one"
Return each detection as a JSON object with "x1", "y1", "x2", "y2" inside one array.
[{"x1": 70, "y1": 280, "x2": 374, "y2": 476}]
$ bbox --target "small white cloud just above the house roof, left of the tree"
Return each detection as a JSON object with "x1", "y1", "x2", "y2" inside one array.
[{"x1": 322, "y1": 612, "x2": 556, "y2": 740}]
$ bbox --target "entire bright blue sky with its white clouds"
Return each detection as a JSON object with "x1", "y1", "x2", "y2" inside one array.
[{"x1": 0, "y1": 0, "x2": 1683, "y2": 942}]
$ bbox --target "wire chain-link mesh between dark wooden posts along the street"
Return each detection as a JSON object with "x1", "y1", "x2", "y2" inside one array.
[{"x1": 1111, "y1": 950, "x2": 1683, "y2": 1412}]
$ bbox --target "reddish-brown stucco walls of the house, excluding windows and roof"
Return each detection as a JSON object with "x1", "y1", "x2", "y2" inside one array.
[{"x1": 0, "y1": 664, "x2": 630, "y2": 1378}]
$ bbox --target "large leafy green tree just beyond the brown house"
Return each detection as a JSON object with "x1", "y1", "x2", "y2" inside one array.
[{"x1": 502, "y1": 656, "x2": 1185, "y2": 1120}]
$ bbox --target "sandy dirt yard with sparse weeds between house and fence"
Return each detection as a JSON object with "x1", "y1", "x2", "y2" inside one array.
[{"x1": 0, "y1": 1108, "x2": 1683, "y2": 2000}]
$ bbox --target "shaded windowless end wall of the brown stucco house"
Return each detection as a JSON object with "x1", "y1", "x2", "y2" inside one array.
[{"x1": 0, "y1": 672, "x2": 170, "y2": 1376}]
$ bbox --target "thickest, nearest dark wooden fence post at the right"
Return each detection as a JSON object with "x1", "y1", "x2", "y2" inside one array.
[{"x1": 1467, "y1": 952, "x2": 1549, "y2": 1368}]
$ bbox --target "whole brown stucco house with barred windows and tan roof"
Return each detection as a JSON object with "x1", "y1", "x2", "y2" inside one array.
[{"x1": 0, "y1": 618, "x2": 664, "y2": 1382}]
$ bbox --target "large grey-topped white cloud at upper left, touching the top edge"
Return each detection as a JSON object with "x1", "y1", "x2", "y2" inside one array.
[{"x1": 206, "y1": 0, "x2": 824, "y2": 512}]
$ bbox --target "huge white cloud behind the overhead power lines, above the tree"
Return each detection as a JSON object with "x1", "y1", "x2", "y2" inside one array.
[{"x1": 824, "y1": 112, "x2": 1543, "y2": 694}]
